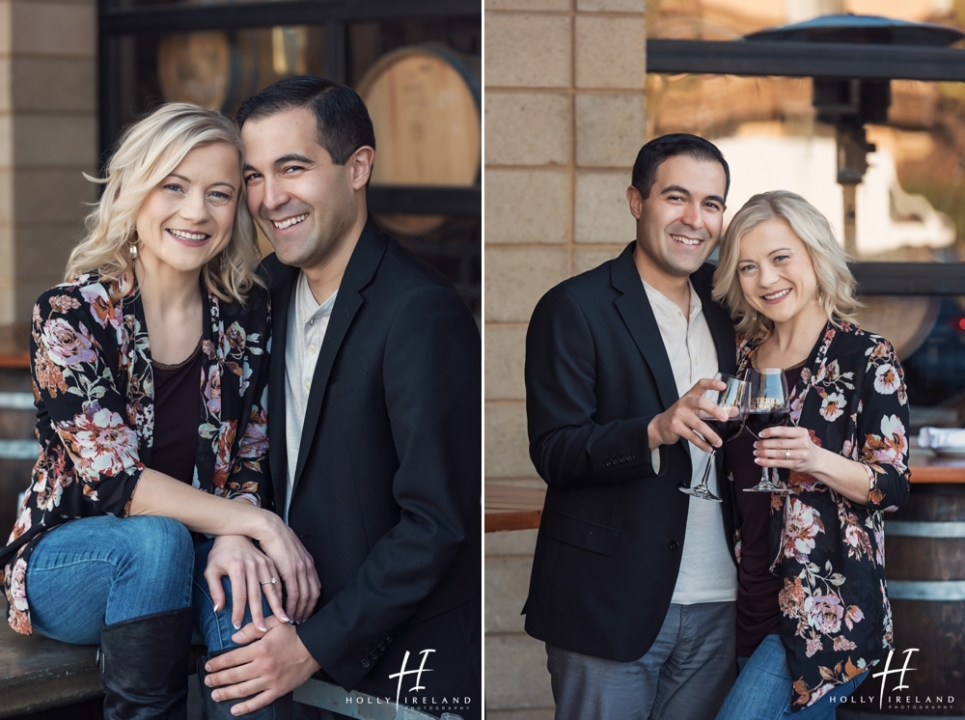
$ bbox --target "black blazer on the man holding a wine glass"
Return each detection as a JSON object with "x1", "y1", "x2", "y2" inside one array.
[{"x1": 524, "y1": 243, "x2": 736, "y2": 662}]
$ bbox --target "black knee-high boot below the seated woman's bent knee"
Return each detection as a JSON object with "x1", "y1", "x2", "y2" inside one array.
[{"x1": 99, "y1": 607, "x2": 194, "y2": 720}]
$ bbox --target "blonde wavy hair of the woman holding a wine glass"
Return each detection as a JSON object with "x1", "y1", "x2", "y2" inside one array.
[{"x1": 713, "y1": 190, "x2": 862, "y2": 340}]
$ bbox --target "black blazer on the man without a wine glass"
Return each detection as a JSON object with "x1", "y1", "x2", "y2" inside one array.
[{"x1": 263, "y1": 218, "x2": 482, "y2": 706}]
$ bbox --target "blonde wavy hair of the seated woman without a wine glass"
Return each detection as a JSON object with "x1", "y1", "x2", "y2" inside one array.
[{"x1": 65, "y1": 103, "x2": 263, "y2": 303}]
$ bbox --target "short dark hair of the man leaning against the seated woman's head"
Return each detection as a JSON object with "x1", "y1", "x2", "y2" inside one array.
[{"x1": 235, "y1": 75, "x2": 375, "y2": 165}]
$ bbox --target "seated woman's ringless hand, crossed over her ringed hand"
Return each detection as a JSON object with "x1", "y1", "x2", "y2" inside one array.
[{"x1": 255, "y1": 511, "x2": 321, "y2": 622}]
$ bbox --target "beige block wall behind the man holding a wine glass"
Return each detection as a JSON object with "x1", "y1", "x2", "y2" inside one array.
[{"x1": 485, "y1": 0, "x2": 646, "y2": 720}]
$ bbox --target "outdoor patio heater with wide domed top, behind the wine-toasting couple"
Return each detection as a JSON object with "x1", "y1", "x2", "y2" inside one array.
[{"x1": 744, "y1": 13, "x2": 965, "y2": 259}]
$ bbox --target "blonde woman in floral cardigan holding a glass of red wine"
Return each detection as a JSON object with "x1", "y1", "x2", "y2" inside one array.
[{"x1": 714, "y1": 191, "x2": 909, "y2": 720}]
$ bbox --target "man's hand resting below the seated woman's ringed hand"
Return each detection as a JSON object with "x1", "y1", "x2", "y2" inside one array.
[{"x1": 204, "y1": 617, "x2": 321, "y2": 715}]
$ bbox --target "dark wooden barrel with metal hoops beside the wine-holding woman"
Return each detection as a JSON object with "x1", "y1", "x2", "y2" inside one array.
[{"x1": 838, "y1": 483, "x2": 965, "y2": 720}]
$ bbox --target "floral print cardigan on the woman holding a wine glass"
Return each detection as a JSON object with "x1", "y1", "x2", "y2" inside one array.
[{"x1": 738, "y1": 323, "x2": 910, "y2": 710}]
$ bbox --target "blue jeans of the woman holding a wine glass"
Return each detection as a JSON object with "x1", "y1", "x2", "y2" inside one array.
[{"x1": 717, "y1": 634, "x2": 868, "y2": 720}]
